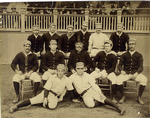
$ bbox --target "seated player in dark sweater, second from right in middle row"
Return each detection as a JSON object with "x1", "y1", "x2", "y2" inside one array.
[{"x1": 91, "y1": 40, "x2": 117, "y2": 103}]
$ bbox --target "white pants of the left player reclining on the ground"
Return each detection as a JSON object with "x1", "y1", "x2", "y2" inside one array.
[{"x1": 30, "y1": 90, "x2": 58, "y2": 109}]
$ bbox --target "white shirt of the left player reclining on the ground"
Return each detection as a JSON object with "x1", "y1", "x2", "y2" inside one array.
[{"x1": 44, "y1": 74, "x2": 68, "y2": 95}]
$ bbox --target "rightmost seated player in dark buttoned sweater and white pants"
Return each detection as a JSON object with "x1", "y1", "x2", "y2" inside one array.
[{"x1": 118, "y1": 38, "x2": 148, "y2": 104}]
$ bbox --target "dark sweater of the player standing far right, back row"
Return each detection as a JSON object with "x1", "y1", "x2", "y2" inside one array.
[{"x1": 110, "y1": 32, "x2": 129, "y2": 52}]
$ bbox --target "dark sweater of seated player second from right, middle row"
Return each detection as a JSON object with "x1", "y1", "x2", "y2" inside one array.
[{"x1": 94, "y1": 51, "x2": 117, "y2": 74}]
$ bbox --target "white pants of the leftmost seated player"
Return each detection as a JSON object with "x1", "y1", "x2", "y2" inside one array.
[{"x1": 13, "y1": 72, "x2": 41, "y2": 82}]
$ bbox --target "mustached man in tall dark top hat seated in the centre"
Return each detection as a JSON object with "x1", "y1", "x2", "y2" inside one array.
[{"x1": 68, "y1": 38, "x2": 92, "y2": 76}]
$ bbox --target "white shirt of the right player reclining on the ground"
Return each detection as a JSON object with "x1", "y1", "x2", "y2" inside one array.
[{"x1": 67, "y1": 72, "x2": 95, "y2": 94}]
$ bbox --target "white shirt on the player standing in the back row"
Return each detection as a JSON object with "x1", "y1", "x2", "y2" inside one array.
[{"x1": 88, "y1": 33, "x2": 109, "y2": 50}]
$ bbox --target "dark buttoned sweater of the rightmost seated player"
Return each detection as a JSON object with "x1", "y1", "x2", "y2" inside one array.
[{"x1": 118, "y1": 51, "x2": 143, "y2": 74}]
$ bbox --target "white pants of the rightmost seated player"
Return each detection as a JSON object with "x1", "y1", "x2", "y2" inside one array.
[{"x1": 117, "y1": 74, "x2": 148, "y2": 86}]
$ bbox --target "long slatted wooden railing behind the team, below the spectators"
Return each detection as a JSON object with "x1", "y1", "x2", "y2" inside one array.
[{"x1": 0, "y1": 10, "x2": 150, "y2": 33}]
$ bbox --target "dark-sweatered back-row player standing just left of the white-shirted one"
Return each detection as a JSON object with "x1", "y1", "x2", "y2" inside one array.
[{"x1": 75, "y1": 21, "x2": 91, "y2": 51}]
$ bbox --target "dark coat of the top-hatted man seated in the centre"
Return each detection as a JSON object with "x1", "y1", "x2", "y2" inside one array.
[{"x1": 68, "y1": 49, "x2": 92, "y2": 70}]
